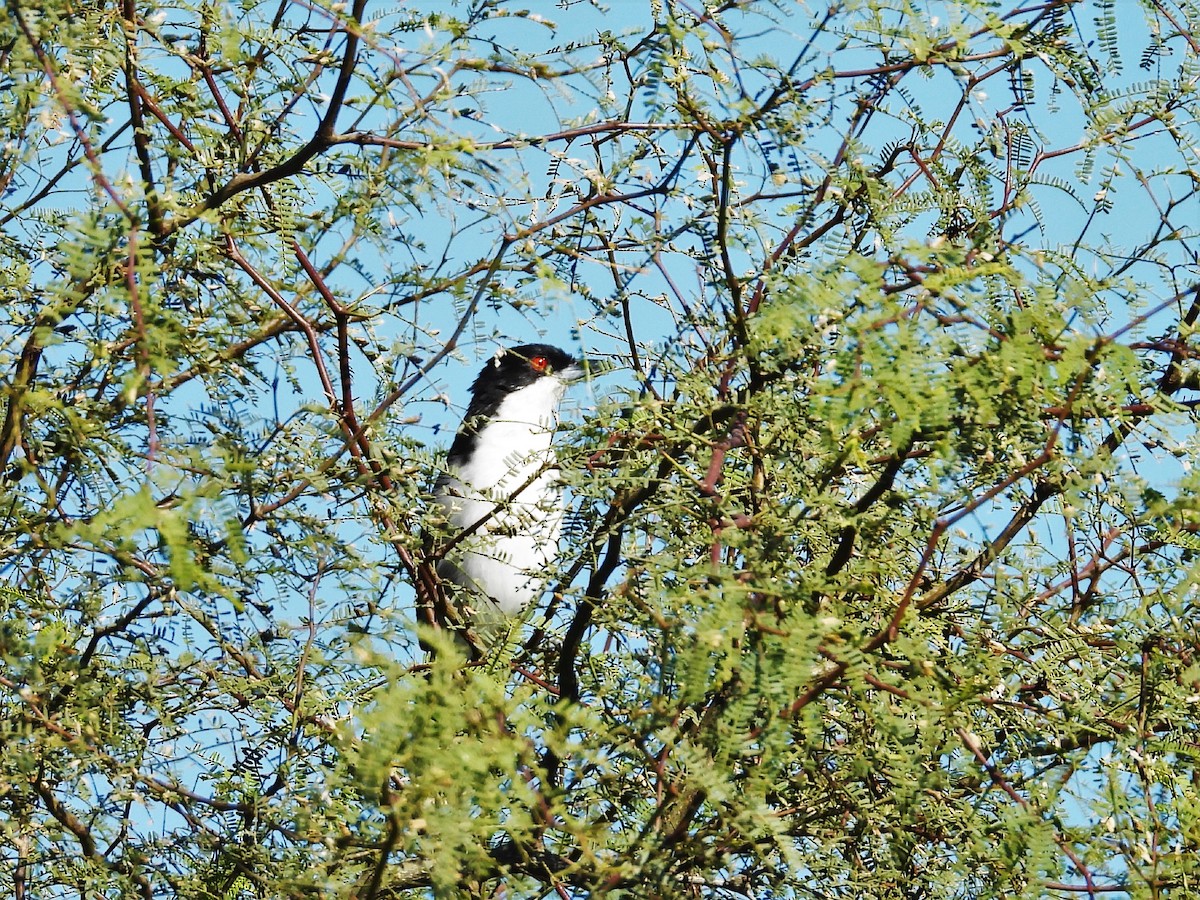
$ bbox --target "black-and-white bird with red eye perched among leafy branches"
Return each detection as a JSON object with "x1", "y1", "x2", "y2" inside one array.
[{"x1": 437, "y1": 343, "x2": 583, "y2": 619}]
